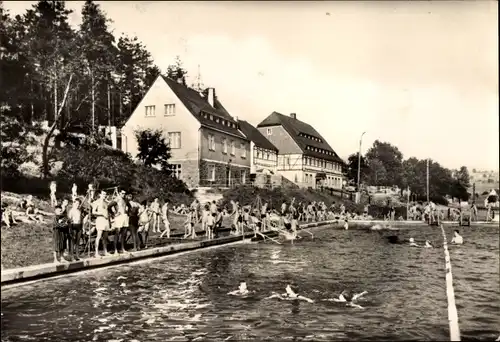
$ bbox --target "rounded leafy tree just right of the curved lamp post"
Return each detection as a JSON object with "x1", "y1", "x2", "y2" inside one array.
[{"x1": 366, "y1": 140, "x2": 403, "y2": 186}]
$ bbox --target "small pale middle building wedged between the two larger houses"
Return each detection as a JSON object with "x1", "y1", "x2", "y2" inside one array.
[{"x1": 238, "y1": 120, "x2": 278, "y2": 174}]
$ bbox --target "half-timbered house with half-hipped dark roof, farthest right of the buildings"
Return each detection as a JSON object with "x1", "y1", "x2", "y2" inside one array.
[{"x1": 257, "y1": 112, "x2": 344, "y2": 189}]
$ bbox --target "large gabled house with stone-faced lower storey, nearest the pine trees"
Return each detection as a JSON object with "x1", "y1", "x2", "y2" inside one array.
[{"x1": 121, "y1": 76, "x2": 250, "y2": 187}]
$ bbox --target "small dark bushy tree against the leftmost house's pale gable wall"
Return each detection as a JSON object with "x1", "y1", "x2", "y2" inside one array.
[{"x1": 135, "y1": 129, "x2": 171, "y2": 171}]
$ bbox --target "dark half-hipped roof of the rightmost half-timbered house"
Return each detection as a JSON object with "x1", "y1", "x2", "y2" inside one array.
[{"x1": 257, "y1": 112, "x2": 344, "y2": 164}]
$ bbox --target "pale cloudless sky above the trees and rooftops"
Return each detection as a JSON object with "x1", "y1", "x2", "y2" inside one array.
[{"x1": 4, "y1": 0, "x2": 499, "y2": 170}]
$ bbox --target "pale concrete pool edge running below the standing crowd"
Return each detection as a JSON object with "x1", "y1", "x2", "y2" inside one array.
[{"x1": 1, "y1": 221, "x2": 336, "y2": 286}]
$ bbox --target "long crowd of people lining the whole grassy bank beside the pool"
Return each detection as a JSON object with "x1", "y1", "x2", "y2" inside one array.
[{"x1": 2, "y1": 182, "x2": 496, "y2": 263}]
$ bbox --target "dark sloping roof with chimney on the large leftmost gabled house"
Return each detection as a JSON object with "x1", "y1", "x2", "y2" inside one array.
[{"x1": 162, "y1": 76, "x2": 245, "y2": 139}]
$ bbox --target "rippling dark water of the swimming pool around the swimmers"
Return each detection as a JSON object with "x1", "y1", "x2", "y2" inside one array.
[{"x1": 1, "y1": 226, "x2": 500, "y2": 341}]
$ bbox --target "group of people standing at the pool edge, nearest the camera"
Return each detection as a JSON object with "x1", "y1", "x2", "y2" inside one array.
[{"x1": 50, "y1": 184, "x2": 176, "y2": 263}]
